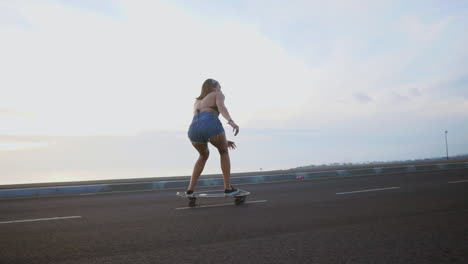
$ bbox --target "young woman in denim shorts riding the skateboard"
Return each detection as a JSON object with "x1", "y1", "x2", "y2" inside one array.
[{"x1": 185, "y1": 79, "x2": 239, "y2": 197}]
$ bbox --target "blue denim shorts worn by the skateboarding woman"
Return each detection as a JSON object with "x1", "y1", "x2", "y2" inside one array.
[{"x1": 188, "y1": 112, "x2": 224, "y2": 143}]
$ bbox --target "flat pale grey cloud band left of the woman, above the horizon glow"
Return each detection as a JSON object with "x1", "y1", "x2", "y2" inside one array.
[{"x1": 0, "y1": 131, "x2": 190, "y2": 170}]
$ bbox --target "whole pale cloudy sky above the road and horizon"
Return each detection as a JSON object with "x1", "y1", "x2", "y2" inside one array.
[{"x1": 0, "y1": 0, "x2": 468, "y2": 185}]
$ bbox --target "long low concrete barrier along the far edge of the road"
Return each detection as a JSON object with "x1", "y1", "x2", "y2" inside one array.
[{"x1": 0, "y1": 162, "x2": 468, "y2": 199}]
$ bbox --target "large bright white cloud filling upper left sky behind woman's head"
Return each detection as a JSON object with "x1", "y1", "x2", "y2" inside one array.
[{"x1": 0, "y1": 1, "x2": 322, "y2": 135}]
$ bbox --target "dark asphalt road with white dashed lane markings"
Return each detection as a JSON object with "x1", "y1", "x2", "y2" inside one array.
[{"x1": 0, "y1": 169, "x2": 468, "y2": 264}]
